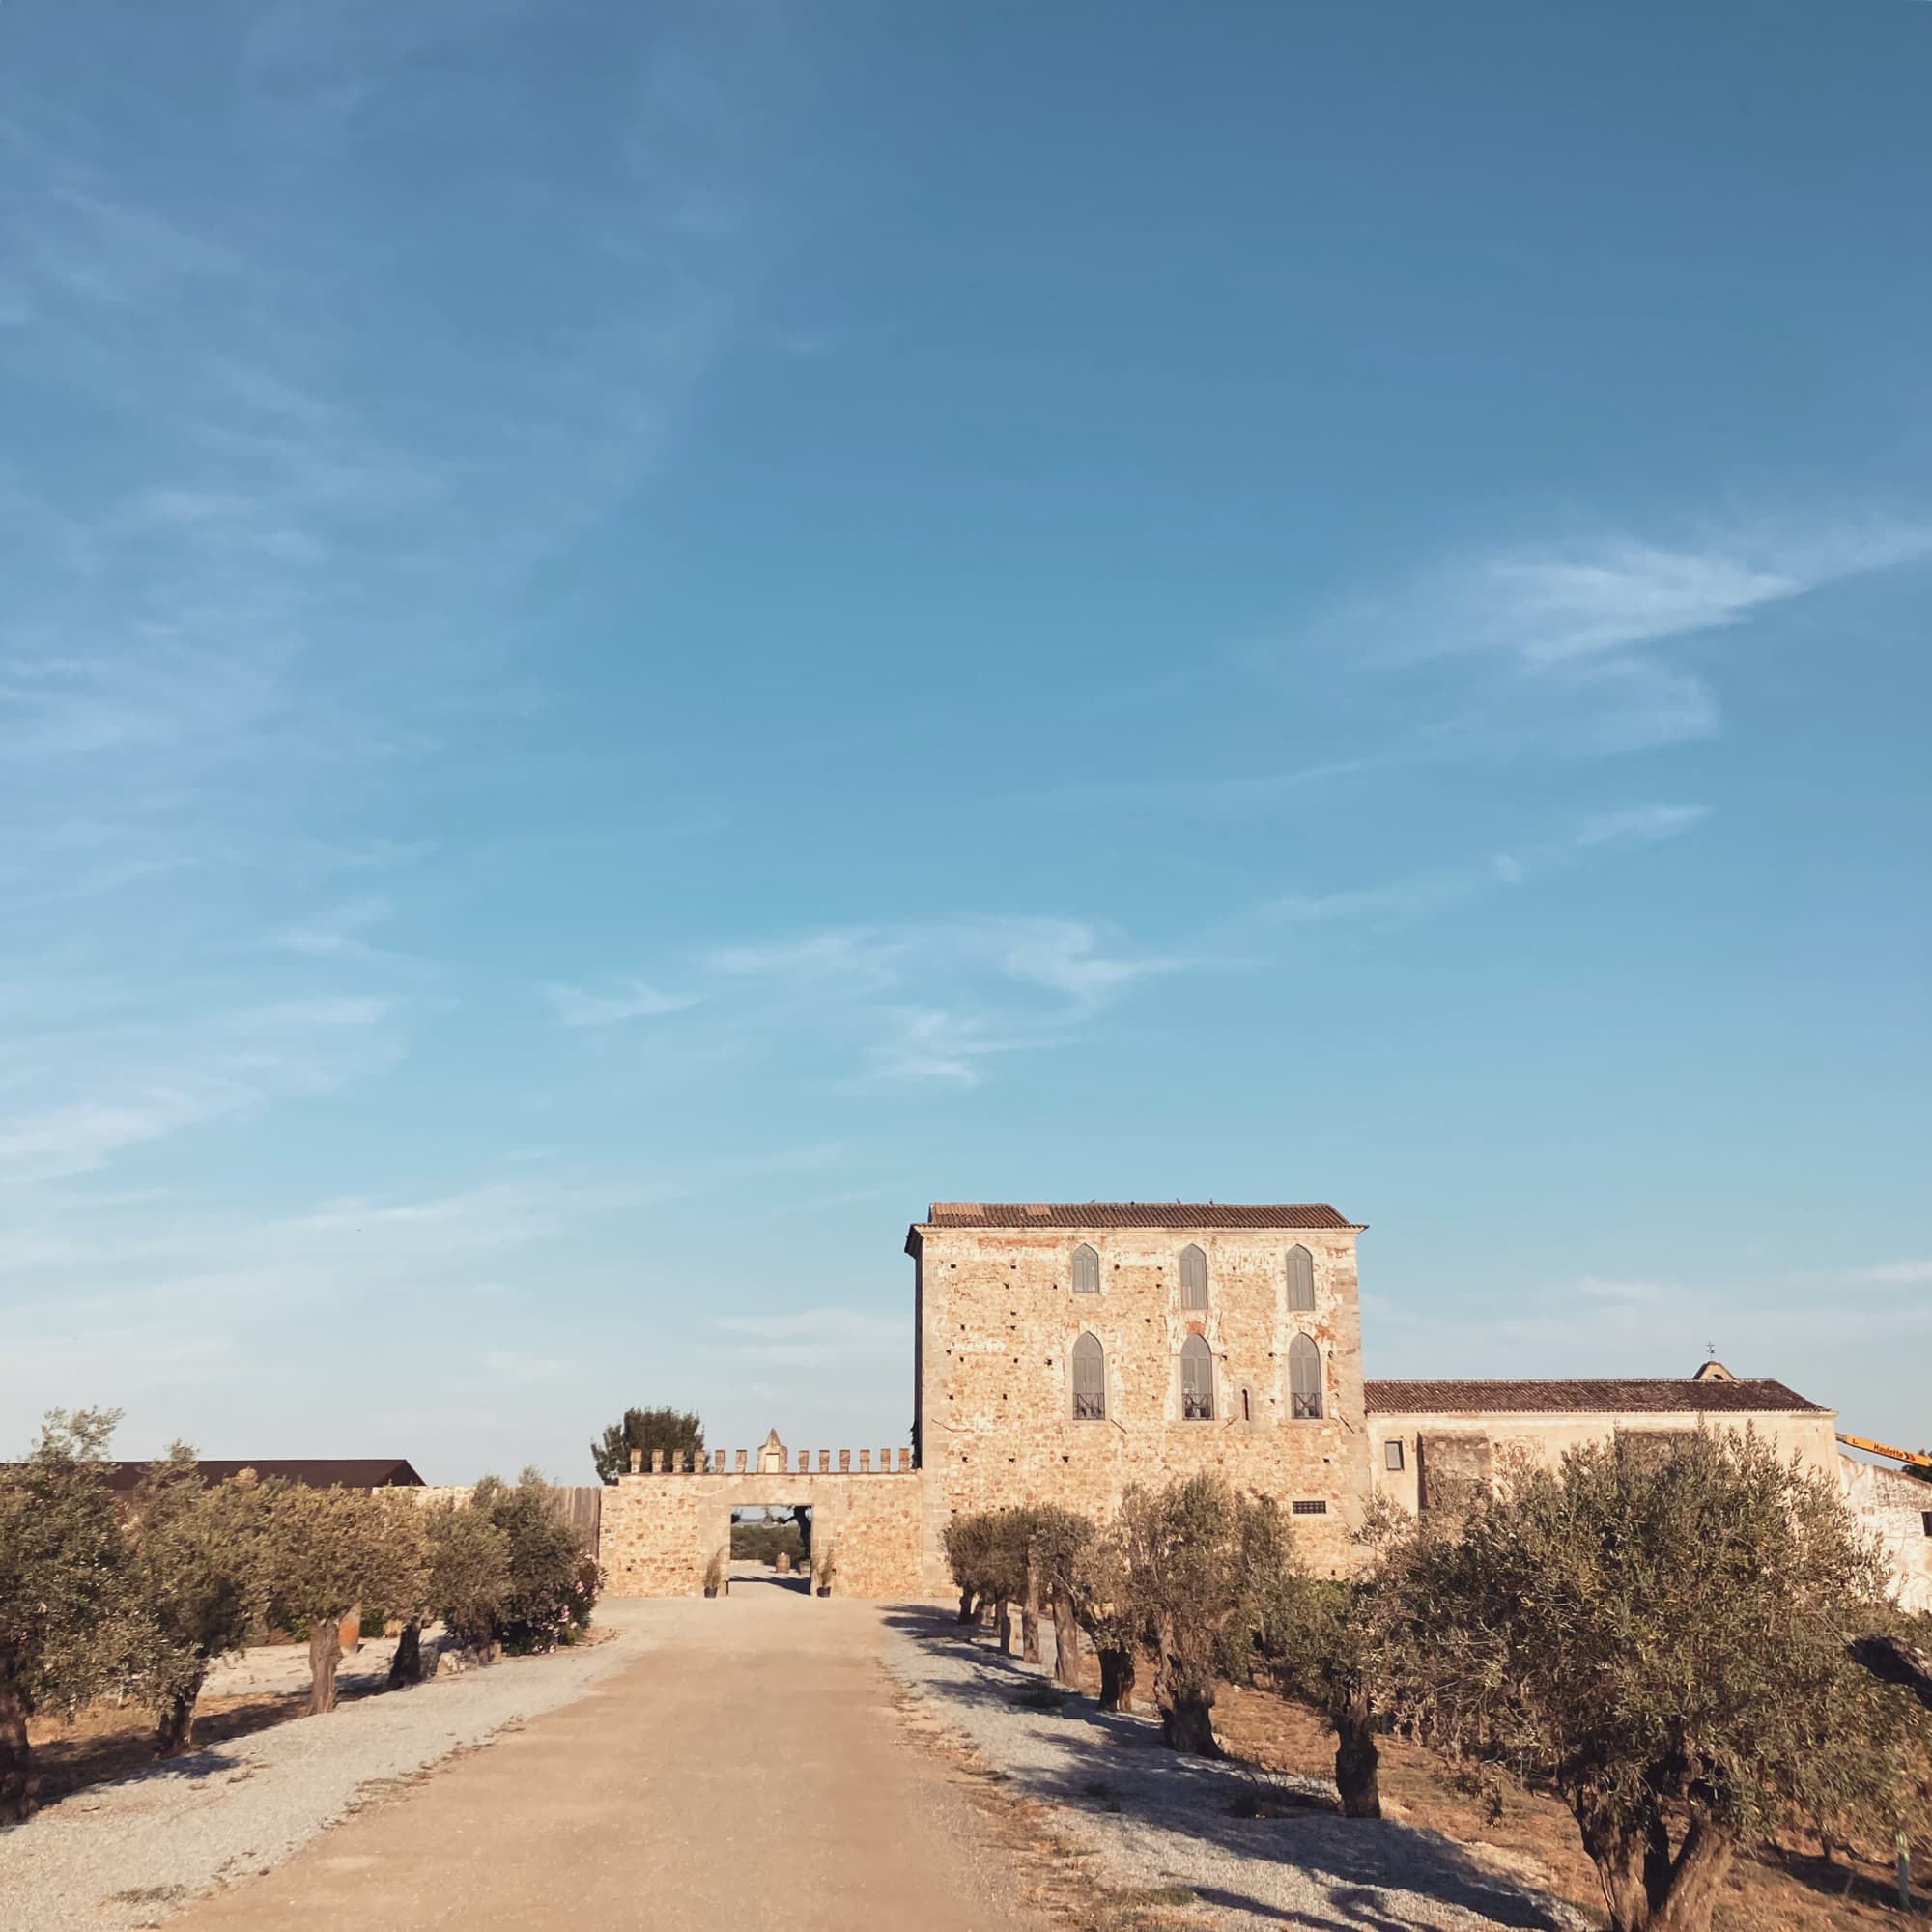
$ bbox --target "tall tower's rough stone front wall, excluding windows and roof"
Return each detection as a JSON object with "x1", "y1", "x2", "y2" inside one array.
[{"x1": 914, "y1": 1225, "x2": 1368, "y2": 1592}]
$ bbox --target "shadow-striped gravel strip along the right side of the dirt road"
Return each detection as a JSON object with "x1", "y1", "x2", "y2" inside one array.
[{"x1": 883, "y1": 1615, "x2": 1588, "y2": 1932}]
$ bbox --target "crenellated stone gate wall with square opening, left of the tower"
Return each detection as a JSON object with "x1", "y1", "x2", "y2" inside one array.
[{"x1": 599, "y1": 1449, "x2": 920, "y2": 1598}]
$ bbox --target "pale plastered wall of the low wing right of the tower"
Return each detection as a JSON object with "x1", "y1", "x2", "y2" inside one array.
[{"x1": 1368, "y1": 1408, "x2": 1839, "y2": 1515}]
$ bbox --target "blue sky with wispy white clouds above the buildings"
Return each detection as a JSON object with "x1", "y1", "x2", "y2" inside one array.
[{"x1": 0, "y1": 0, "x2": 1932, "y2": 1480}]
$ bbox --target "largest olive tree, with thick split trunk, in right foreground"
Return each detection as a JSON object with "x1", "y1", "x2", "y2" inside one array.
[{"x1": 1387, "y1": 1432, "x2": 1917, "y2": 1932}]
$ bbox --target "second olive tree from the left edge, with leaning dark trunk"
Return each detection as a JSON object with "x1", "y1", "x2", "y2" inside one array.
[{"x1": 128, "y1": 1443, "x2": 269, "y2": 1758}]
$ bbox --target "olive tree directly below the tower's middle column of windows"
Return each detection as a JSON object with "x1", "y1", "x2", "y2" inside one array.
[{"x1": 1117, "y1": 1472, "x2": 1294, "y2": 1758}]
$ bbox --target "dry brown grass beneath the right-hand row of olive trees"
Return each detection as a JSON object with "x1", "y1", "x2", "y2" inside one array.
[{"x1": 1215, "y1": 1689, "x2": 1932, "y2": 1932}]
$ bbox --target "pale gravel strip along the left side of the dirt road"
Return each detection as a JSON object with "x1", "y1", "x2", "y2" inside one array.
[{"x1": 0, "y1": 1605, "x2": 655, "y2": 1932}]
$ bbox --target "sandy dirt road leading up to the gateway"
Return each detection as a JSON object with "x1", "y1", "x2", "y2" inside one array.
[{"x1": 168, "y1": 1582, "x2": 1039, "y2": 1932}]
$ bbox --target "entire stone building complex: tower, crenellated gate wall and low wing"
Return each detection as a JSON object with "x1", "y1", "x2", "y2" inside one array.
[{"x1": 601, "y1": 1202, "x2": 1932, "y2": 1598}]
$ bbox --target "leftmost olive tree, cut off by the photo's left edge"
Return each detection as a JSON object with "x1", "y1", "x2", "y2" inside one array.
[{"x1": 0, "y1": 1408, "x2": 139, "y2": 1824}]
